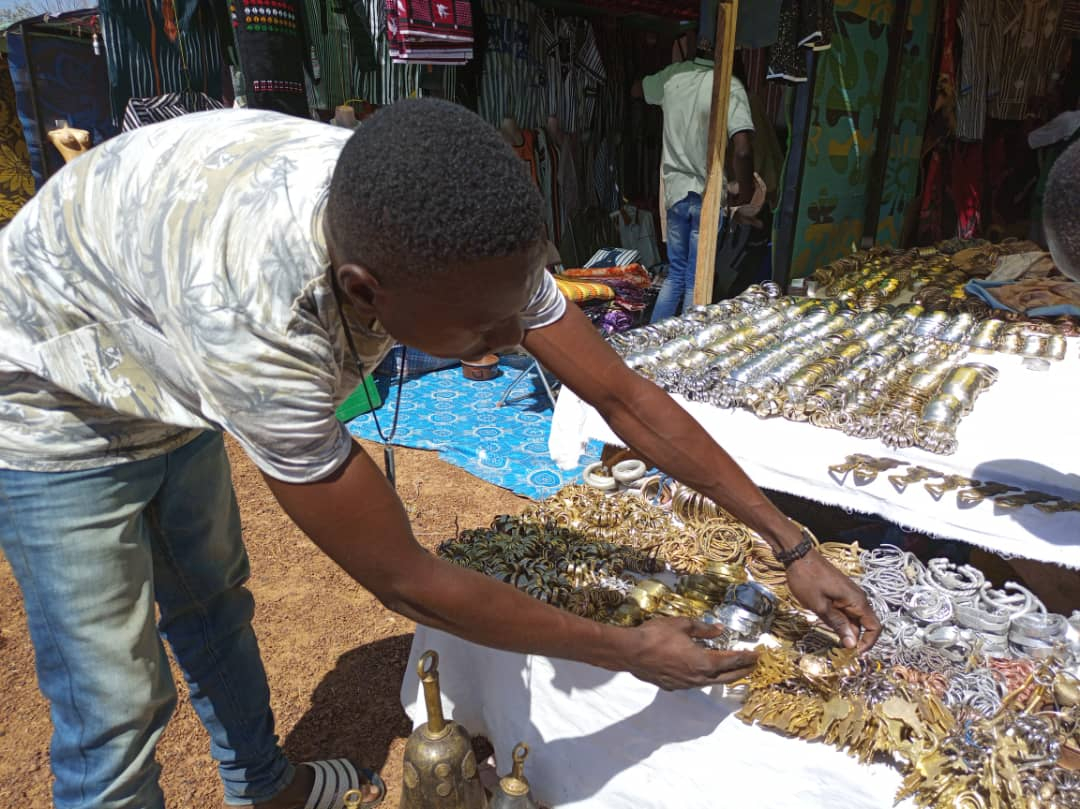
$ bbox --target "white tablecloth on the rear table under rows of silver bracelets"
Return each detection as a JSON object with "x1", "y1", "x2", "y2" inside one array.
[{"x1": 549, "y1": 339, "x2": 1080, "y2": 568}]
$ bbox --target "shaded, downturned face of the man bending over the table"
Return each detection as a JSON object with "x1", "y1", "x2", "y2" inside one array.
[{"x1": 373, "y1": 245, "x2": 544, "y2": 360}]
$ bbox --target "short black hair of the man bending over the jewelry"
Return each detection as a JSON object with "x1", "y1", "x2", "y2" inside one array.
[{"x1": 326, "y1": 98, "x2": 544, "y2": 283}]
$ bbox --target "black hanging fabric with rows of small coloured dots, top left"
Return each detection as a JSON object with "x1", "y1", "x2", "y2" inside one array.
[{"x1": 229, "y1": 0, "x2": 311, "y2": 118}]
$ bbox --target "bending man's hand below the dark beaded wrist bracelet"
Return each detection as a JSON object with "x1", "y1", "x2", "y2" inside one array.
[{"x1": 787, "y1": 551, "x2": 881, "y2": 651}]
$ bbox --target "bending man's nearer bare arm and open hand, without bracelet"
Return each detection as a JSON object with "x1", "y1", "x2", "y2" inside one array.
[{"x1": 265, "y1": 445, "x2": 755, "y2": 688}]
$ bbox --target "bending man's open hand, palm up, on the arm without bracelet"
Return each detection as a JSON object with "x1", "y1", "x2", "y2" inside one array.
[{"x1": 626, "y1": 618, "x2": 757, "y2": 691}]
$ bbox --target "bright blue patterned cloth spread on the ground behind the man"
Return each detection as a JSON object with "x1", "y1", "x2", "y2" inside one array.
[{"x1": 349, "y1": 356, "x2": 603, "y2": 500}]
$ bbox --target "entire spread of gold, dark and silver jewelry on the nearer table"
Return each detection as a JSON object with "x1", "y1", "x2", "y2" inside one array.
[{"x1": 440, "y1": 478, "x2": 1080, "y2": 809}]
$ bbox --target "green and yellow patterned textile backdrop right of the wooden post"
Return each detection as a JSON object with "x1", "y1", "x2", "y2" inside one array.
[{"x1": 792, "y1": 0, "x2": 935, "y2": 278}]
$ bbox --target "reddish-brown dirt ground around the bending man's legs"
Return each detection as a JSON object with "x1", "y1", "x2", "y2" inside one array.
[{"x1": 0, "y1": 444, "x2": 528, "y2": 809}]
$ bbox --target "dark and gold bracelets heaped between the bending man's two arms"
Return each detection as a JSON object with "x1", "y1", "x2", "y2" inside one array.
[{"x1": 438, "y1": 478, "x2": 838, "y2": 642}]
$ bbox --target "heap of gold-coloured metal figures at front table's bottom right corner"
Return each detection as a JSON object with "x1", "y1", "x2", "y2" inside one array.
[{"x1": 739, "y1": 647, "x2": 1080, "y2": 809}]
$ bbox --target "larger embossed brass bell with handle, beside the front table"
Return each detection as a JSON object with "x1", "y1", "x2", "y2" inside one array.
[{"x1": 400, "y1": 651, "x2": 487, "y2": 809}]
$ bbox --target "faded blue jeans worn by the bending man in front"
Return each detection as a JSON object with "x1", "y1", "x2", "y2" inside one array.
[{"x1": 0, "y1": 432, "x2": 293, "y2": 809}]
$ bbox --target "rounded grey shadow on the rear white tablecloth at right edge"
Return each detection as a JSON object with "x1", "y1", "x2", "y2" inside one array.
[{"x1": 971, "y1": 458, "x2": 1080, "y2": 545}]
